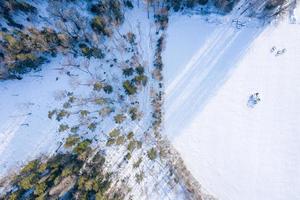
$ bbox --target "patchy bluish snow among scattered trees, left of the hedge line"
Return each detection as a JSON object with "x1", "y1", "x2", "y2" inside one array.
[{"x1": 0, "y1": 4, "x2": 189, "y2": 199}]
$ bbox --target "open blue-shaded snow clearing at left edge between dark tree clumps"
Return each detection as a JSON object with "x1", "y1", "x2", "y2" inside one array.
[{"x1": 0, "y1": 57, "x2": 68, "y2": 177}]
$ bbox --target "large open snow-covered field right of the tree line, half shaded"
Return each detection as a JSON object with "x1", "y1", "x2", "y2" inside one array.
[{"x1": 164, "y1": 4, "x2": 300, "y2": 200}]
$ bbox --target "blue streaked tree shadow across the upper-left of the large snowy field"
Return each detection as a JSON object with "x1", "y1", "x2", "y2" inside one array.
[{"x1": 163, "y1": 14, "x2": 264, "y2": 139}]
